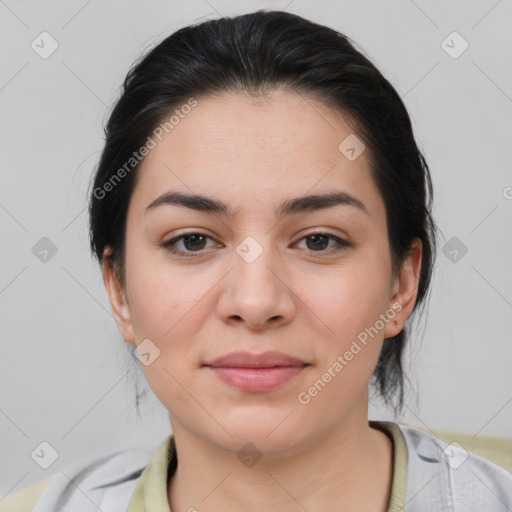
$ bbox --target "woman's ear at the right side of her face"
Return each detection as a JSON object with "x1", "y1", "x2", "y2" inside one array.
[{"x1": 384, "y1": 238, "x2": 423, "y2": 338}]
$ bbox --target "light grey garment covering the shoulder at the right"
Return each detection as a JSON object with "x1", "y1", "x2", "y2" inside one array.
[{"x1": 397, "y1": 424, "x2": 512, "y2": 512}]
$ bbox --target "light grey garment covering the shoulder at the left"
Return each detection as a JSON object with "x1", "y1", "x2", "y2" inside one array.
[{"x1": 0, "y1": 442, "x2": 156, "y2": 512}]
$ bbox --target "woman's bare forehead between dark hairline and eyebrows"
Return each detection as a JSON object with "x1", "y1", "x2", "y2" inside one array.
[{"x1": 130, "y1": 91, "x2": 378, "y2": 220}]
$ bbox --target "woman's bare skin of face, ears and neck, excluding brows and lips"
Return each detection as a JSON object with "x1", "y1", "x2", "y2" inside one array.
[{"x1": 103, "y1": 91, "x2": 421, "y2": 512}]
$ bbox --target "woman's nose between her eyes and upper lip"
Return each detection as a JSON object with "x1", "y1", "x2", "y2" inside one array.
[{"x1": 217, "y1": 238, "x2": 297, "y2": 330}]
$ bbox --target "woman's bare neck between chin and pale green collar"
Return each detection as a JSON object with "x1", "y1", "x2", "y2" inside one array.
[{"x1": 168, "y1": 416, "x2": 393, "y2": 512}]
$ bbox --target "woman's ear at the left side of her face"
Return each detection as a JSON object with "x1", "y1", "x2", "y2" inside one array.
[{"x1": 102, "y1": 248, "x2": 135, "y2": 345}]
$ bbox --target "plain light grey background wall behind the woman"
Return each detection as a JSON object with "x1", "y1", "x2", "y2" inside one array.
[{"x1": 0, "y1": 0, "x2": 512, "y2": 494}]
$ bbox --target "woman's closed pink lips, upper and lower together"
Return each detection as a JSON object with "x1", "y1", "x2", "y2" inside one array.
[{"x1": 204, "y1": 352, "x2": 309, "y2": 392}]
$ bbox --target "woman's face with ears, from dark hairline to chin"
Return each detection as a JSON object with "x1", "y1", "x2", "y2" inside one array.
[{"x1": 104, "y1": 91, "x2": 420, "y2": 453}]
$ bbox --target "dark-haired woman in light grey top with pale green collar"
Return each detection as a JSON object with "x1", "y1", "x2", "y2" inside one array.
[{"x1": 5, "y1": 11, "x2": 512, "y2": 512}]
